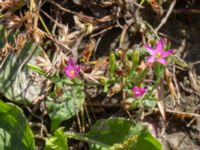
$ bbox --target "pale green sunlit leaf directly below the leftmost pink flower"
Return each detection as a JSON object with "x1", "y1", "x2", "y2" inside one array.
[{"x1": 46, "y1": 85, "x2": 85, "y2": 131}]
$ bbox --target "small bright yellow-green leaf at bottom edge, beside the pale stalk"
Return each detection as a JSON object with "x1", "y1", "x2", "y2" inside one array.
[{"x1": 44, "y1": 128, "x2": 68, "y2": 150}]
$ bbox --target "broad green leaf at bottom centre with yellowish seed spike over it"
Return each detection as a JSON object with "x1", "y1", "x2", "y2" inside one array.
[{"x1": 86, "y1": 118, "x2": 162, "y2": 150}]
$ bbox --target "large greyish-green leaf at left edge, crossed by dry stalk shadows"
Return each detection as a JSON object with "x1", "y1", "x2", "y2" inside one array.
[{"x1": 0, "y1": 42, "x2": 46, "y2": 104}]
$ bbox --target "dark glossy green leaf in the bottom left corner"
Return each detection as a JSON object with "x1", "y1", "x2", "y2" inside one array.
[{"x1": 0, "y1": 101, "x2": 35, "y2": 150}]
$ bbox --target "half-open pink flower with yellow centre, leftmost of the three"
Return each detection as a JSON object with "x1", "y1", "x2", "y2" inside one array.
[{"x1": 64, "y1": 57, "x2": 80, "y2": 80}]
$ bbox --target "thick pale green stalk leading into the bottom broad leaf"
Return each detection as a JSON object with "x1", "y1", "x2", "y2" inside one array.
[{"x1": 65, "y1": 131, "x2": 109, "y2": 147}]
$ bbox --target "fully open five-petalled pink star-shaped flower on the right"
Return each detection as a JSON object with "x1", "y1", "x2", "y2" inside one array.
[{"x1": 144, "y1": 39, "x2": 174, "y2": 65}]
